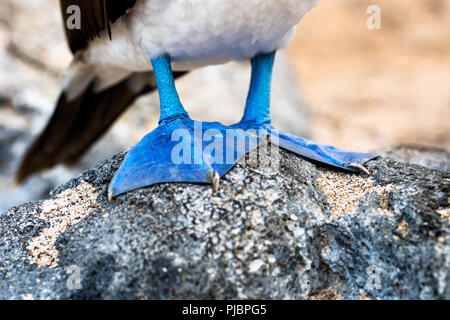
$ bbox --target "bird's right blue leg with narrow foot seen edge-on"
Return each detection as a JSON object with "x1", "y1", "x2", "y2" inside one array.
[{"x1": 233, "y1": 53, "x2": 376, "y2": 172}]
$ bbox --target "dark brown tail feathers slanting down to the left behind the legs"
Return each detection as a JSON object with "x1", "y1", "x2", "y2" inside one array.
[{"x1": 16, "y1": 72, "x2": 182, "y2": 183}]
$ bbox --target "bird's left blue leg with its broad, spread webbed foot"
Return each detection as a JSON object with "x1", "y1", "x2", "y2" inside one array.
[{"x1": 108, "y1": 57, "x2": 258, "y2": 199}]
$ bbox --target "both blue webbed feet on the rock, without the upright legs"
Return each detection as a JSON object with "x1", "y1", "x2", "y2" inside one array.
[{"x1": 108, "y1": 117, "x2": 376, "y2": 198}]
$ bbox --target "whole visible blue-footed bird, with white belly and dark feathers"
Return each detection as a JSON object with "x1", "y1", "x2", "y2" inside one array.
[{"x1": 17, "y1": 0, "x2": 374, "y2": 198}]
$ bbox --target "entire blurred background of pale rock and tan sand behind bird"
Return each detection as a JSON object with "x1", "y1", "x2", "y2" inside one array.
[{"x1": 0, "y1": 0, "x2": 450, "y2": 211}]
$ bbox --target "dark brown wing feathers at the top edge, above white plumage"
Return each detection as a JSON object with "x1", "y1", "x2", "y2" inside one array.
[{"x1": 60, "y1": 0, "x2": 137, "y2": 54}]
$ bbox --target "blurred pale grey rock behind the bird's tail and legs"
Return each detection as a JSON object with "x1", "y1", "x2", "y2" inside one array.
[{"x1": 0, "y1": 0, "x2": 309, "y2": 211}]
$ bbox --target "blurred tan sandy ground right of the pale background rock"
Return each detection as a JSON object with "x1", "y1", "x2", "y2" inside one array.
[{"x1": 288, "y1": 0, "x2": 450, "y2": 150}]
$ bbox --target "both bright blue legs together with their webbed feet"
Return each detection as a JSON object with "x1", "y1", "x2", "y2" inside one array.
[{"x1": 109, "y1": 52, "x2": 376, "y2": 198}]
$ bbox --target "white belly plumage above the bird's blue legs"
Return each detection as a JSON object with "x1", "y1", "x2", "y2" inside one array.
[{"x1": 85, "y1": 0, "x2": 318, "y2": 71}]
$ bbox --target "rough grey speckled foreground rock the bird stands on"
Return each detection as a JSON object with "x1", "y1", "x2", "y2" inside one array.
[{"x1": 0, "y1": 146, "x2": 450, "y2": 299}]
